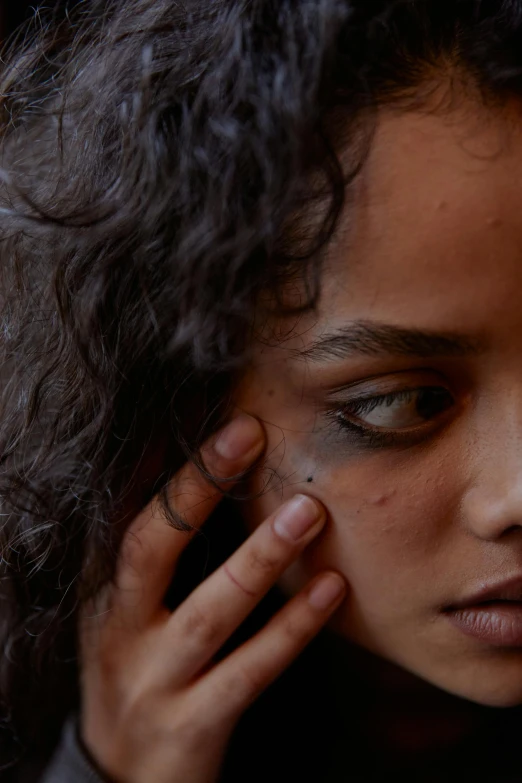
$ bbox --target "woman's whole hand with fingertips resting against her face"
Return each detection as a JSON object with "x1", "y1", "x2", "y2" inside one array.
[{"x1": 80, "y1": 415, "x2": 345, "y2": 783}]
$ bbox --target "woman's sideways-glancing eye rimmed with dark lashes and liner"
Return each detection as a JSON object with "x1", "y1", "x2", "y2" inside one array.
[{"x1": 326, "y1": 386, "x2": 454, "y2": 448}]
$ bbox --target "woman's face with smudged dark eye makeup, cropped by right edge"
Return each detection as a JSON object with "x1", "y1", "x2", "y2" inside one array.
[{"x1": 237, "y1": 95, "x2": 522, "y2": 706}]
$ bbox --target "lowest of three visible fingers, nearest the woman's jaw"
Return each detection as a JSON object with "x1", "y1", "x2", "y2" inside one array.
[{"x1": 196, "y1": 572, "x2": 346, "y2": 720}]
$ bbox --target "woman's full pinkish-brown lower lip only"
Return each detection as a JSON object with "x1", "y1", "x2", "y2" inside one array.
[{"x1": 447, "y1": 601, "x2": 522, "y2": 647}]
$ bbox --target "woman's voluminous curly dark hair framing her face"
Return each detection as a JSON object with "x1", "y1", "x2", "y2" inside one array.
[{"x1": 0, "y1": 0, "x2": 522, "y2": 767}]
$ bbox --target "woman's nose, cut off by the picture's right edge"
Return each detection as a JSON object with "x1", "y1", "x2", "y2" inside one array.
[{"x1": 462, "y1": 405, "x2": 522, "y2": 541}]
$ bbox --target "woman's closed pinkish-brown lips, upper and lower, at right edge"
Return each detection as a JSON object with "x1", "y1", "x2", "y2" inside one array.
[{"x1": 444, "y1": 575, "x2": 522, "y2": 648}]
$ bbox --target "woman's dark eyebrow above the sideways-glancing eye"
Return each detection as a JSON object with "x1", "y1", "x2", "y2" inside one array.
[{"x1": 290, "y1": 321, "x2": 486, "y2": 362}]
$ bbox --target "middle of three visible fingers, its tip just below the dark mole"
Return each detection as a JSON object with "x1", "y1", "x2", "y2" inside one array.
[{"x1": 164, "y1": 495, "x2": 326, "y2": 685}]
